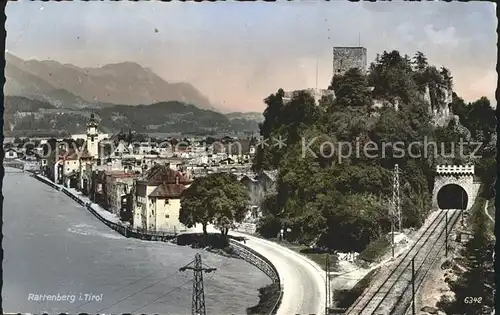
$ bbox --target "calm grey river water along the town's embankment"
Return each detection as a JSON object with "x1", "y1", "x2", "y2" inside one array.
[{"x1": 2, "y1": 170, "x2": 271, "y2": 314}]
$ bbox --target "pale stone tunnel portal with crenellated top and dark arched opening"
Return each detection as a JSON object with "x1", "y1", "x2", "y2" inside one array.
[{"x1": 432, "y1": 165, "x2": 480, "y2": 210}]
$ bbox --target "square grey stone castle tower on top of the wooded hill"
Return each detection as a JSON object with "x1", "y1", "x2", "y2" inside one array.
[{"x1": 333, "y1": 47, "x2": 367, "y2": 75}]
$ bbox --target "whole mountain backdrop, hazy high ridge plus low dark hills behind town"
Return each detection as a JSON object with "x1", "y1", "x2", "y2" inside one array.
[{"x1": 4, "y1": 53, "x2": 264, "y2": 135}]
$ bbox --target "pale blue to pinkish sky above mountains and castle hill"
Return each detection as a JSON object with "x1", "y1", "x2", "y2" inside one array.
[{"x1": 6, "y1": 1, "x2": 497, "y2": 112}]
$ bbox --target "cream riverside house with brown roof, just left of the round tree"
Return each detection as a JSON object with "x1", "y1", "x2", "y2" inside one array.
[{"x1": 133, "y1": 164, "x2": 191, "y2": 233}]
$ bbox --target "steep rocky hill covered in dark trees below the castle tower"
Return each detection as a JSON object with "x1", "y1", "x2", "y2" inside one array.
[{"x1": 254, "y1": 51, "x2": 496, "y2": 251}]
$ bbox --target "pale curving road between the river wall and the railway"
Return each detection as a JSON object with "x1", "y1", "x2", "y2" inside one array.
[{"x1": 201, "y1": 226, "x2": 326, "y2": 315}]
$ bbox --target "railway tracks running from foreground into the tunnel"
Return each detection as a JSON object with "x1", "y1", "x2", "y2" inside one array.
[{"x1": 346, "y1": 210, "x2": 460, "y2": 315}]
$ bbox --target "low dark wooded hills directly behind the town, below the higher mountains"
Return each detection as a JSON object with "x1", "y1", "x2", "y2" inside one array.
[{"x1": 4, "y1": 96, "x2": 258, "y2": 136}]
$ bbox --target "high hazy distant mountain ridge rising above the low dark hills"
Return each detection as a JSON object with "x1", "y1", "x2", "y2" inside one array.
[{"x1": 4, "y1": 53, "x2": 217, "y2": 110}]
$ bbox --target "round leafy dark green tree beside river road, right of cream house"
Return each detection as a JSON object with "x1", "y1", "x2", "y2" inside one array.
[{"x1": 179, "y1": 173, "x2": 249, "y2": 236}]
